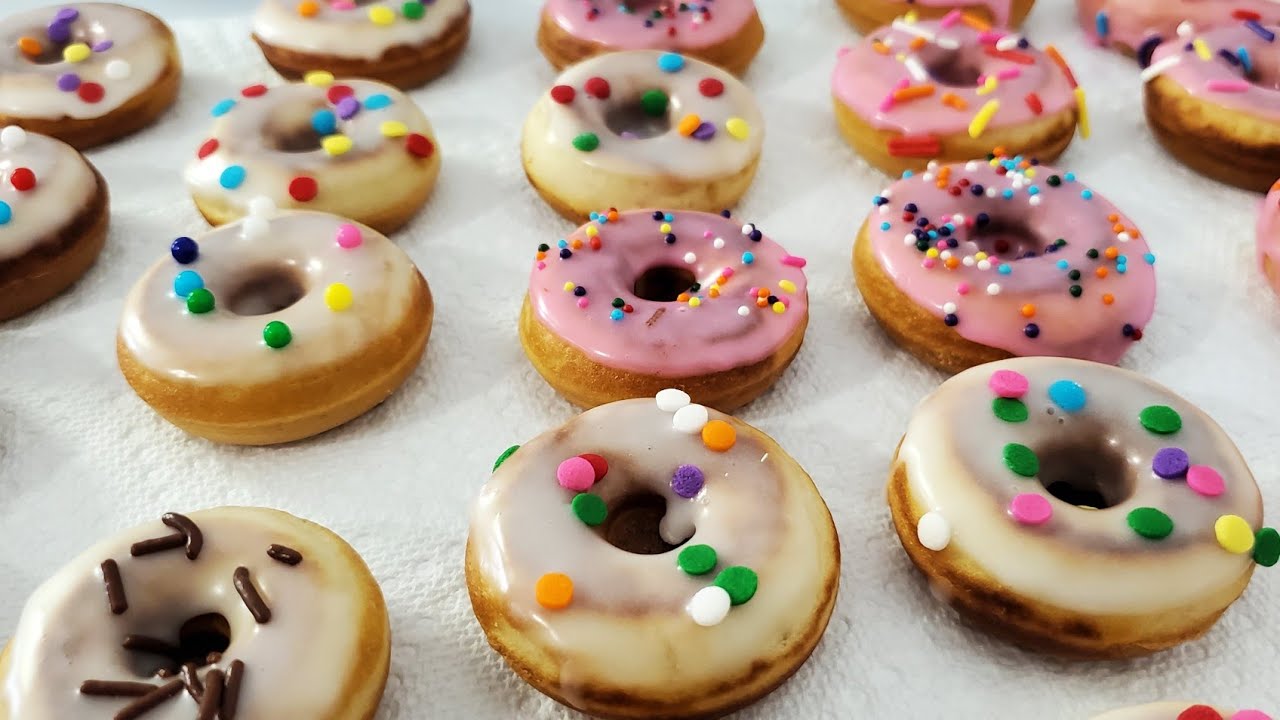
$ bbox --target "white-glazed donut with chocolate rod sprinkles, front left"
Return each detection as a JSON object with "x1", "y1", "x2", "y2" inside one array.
[{"x1": 0, "y1": 507, "x2": 390, "y2": 720}]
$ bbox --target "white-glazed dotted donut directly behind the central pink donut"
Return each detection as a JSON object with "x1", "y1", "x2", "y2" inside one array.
[{"x1": 521, "y1": 50, "x2": 764, "y2": 222}]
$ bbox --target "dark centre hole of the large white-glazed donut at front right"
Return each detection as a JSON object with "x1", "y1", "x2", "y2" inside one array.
[{"x1": 1037, "y1": 438, "x2": 1134, "y2": 510}]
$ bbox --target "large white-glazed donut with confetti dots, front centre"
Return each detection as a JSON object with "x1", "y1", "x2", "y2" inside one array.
[{"x1": 466, "y1": 389, "x2": 840, "y2": 720}]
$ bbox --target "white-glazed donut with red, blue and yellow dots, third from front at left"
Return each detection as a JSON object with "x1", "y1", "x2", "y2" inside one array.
[{"x1": 186, "y1": 72, "x2": 440, "y2": 233}]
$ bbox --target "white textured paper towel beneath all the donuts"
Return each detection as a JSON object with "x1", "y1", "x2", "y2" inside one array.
[{"x1": 0, "y1": 0, "x2": 1280, "y2": 720}]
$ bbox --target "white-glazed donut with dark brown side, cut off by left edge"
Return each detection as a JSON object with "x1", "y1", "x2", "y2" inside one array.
[{"x1": 0, "y1": 126, "x2": 109, "y2": 320}]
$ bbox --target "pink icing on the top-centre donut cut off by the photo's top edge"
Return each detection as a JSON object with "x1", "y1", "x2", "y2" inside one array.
[{"x1": 544, "y1": 0, "x2": 755, "y2": 51}]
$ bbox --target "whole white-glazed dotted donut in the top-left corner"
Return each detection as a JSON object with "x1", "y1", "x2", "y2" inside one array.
[{"x1": 0, "y1": 3, "x2": 182, "y2": 150}]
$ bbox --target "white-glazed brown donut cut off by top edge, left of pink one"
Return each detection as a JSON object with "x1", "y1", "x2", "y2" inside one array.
[{"x1": 253, "y1": 0, "x2": 471, "y2": 90}]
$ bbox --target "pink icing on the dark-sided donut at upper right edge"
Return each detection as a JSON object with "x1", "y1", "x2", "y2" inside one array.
[{"x1": 1151, "y1": 24, "x2": 1280, "y2": 119}]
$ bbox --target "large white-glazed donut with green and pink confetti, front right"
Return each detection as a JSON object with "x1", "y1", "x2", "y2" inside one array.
[{"x1": 888, "y1": 357, "x2": 1280, "y2": 659}]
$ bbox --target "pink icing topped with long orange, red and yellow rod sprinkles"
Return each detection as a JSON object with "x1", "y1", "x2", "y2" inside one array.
[{"x1": 831, "y1": 20, "x2": 1075, "y2": 135}]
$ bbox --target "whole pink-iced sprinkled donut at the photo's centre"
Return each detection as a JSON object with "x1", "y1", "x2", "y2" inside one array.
[{"x1": 520, "y1": 210, "x2": 809, "y2": 411}]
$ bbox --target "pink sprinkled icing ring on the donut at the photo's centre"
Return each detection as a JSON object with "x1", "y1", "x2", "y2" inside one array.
[{"x1": 529, "y1": 210, "x2": 809, "y2": 378}]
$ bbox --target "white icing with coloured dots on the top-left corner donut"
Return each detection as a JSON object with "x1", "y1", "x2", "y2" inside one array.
[{"x1": 0, "y1": 3, "x2": 173, "y2": 119}]
